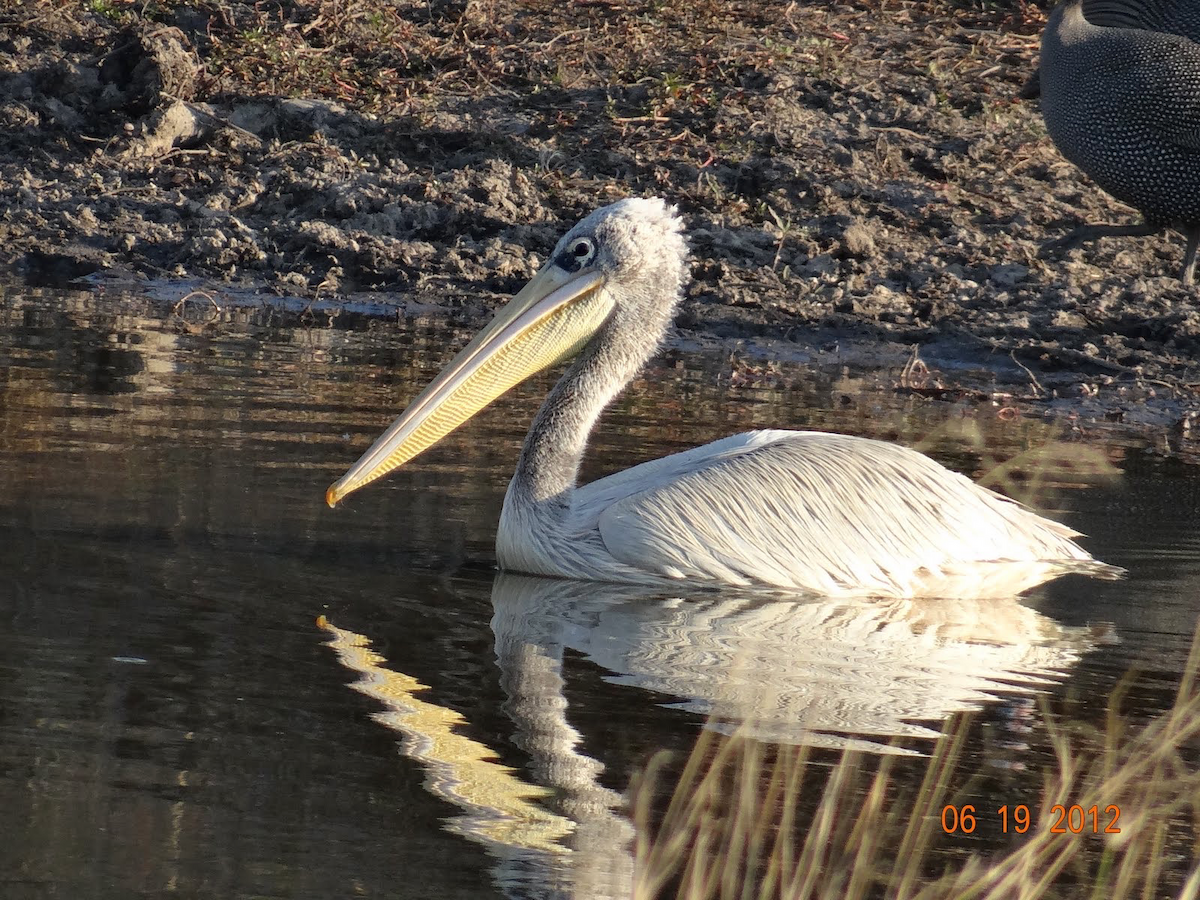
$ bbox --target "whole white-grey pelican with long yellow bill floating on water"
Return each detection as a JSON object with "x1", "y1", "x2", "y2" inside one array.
[{"x1": 325, "y1": 199, "x2": 1121, "y2": 598}]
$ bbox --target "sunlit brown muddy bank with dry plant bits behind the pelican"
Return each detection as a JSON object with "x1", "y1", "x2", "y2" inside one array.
[{"x1": 0, "y1": 0, "x2": 1200, "y2": 430}]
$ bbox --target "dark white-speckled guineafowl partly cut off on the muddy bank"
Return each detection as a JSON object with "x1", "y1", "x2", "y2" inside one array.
[{"x1": 1025, "y1": 0, "x2": 1200, "y2": 284}]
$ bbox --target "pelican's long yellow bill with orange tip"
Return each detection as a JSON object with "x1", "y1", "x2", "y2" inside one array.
[{"x1": 325, "y1": 263, "x2": 613, "y2": 506}]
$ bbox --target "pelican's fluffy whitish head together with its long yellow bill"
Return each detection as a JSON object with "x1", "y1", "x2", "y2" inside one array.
[{"x1": 325, "y1": 198, "x2": 686, "y2": 506}]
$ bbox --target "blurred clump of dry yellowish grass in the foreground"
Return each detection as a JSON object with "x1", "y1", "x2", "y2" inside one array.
[{"x1": 634, "y1": 635, "x2": 1200, "y2": 900}]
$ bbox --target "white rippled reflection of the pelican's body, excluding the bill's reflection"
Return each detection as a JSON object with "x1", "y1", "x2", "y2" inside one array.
[{"x1": 492, "y1": 572, "x2": 1112, "y2": 762}]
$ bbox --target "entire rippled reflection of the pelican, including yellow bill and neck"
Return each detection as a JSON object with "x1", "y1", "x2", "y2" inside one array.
[{"x1": 322, "y1": 572, "x2": 1103, "y2": 900}]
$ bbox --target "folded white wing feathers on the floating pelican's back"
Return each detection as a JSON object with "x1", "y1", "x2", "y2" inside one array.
[{"x1": 583, "y1": 431, "x2": 1097, "y2": 596}]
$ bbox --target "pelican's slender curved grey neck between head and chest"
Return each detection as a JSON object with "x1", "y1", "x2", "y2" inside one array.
[{"x1": 505, "y1": 324, "x2": 661, "y2": 511}]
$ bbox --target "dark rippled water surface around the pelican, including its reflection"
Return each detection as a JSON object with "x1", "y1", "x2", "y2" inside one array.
[{"x1": 0, "y1": 287, "x2": 1200, "y2": 900}]
